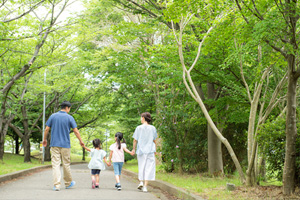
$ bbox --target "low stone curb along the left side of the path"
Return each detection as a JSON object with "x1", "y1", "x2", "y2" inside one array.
[{"x1": 0, "y1": 162, "x2": 86, "y2": 183}]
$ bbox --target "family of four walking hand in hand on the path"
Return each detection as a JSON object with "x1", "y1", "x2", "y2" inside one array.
[{"x1": 43, "y1": 101, "x2": 157, "y2": 192}]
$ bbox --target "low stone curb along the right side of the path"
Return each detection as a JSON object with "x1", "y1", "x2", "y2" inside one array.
[{"x1": 122, "y1": 169, "x2": 205, "y2": 200}]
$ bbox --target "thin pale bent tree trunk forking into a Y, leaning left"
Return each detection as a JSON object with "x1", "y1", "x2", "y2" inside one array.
[{"x1": 172, "y1": 15, "x2": 245, "y2": 183}]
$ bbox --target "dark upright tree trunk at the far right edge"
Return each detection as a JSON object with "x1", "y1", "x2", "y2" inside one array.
[{"x1": 283, "y1": 55, "x2": 297, "y2": 195}]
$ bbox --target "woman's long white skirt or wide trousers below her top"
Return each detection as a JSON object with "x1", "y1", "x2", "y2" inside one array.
[{"x1": 137, "y1": 153, "x2": 155, "y2": 181}]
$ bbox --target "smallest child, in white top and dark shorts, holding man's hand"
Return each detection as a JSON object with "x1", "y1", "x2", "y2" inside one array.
[{"x1": 83, "y1": 139, "x2": 110, "y2": 189}]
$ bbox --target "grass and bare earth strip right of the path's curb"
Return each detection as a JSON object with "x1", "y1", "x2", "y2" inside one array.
[{"x1": 124, "y1": 160, "x2": 282, "y2": 200}]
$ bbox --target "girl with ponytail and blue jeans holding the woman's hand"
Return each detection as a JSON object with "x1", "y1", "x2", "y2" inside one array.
[{"x1": 109, "y1": 132, "x2": 132, "y2": 190}]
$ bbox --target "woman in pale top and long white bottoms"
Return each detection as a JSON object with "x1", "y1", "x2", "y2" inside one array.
[{"x1": 132, "y1": 112, "x2": 157, "y2": 192}]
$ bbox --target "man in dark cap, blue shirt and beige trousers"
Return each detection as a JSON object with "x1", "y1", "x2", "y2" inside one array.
[{"x1": 43, "y1": 101, "x2": 84, "y2": 191}]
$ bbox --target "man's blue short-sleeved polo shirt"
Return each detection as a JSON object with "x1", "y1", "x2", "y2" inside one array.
[{"x1": 46, "y1": 111, "x2": 77, "y2": 148}]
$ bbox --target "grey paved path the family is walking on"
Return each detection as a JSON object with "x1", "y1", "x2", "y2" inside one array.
[{"x1": 0, "y1": 164, "x2": 159, "y2": 200}]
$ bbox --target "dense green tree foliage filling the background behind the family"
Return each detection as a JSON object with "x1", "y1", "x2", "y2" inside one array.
[{"x1": 0, "y1": 0, "x2": 299, "y2": 194}]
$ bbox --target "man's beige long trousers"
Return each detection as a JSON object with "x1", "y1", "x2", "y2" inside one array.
[{"x1": 51, "y1": 147, "x2": 72, "y2": 188}]
